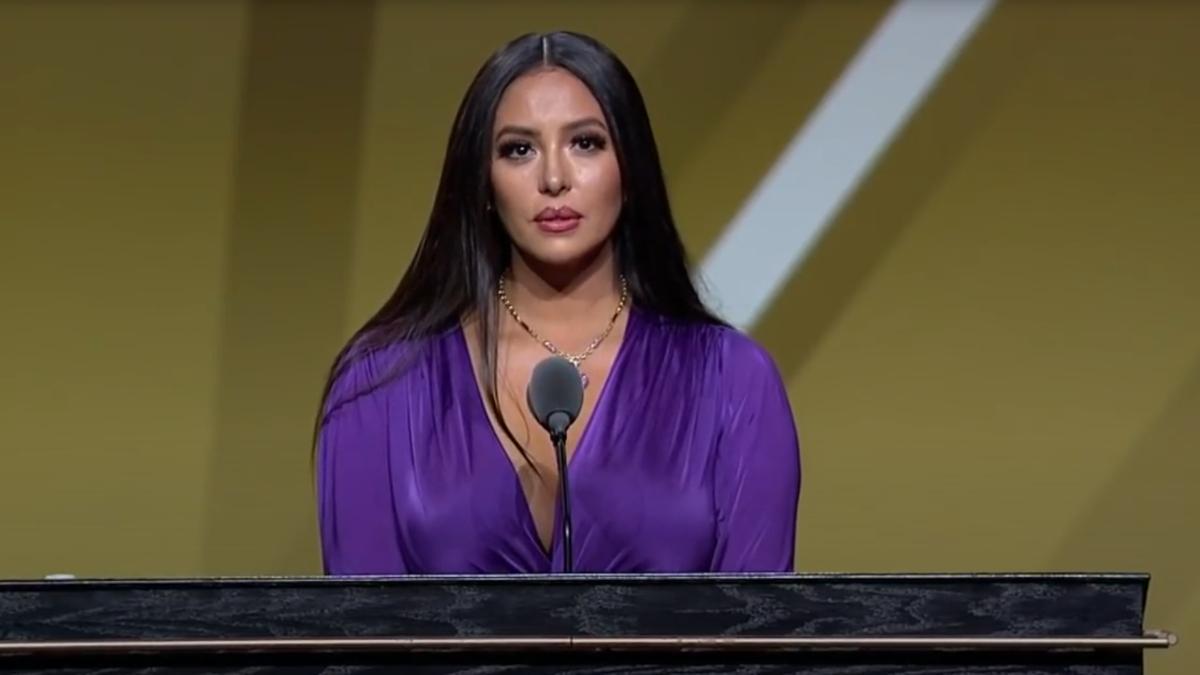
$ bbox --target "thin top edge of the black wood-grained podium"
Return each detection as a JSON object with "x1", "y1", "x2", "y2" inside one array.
[{"x1": 0, "y1": 572, "x2": 1150, "y2": 591}]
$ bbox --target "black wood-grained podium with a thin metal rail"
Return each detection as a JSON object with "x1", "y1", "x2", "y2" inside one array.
[{"x1": 0, "y1": 574, "x2": 1175, "y2": 675}]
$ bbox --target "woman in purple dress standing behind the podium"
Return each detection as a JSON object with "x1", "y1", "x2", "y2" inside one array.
[{"x1": 317, "y1": 32, "x2": 799, "y2": 566}]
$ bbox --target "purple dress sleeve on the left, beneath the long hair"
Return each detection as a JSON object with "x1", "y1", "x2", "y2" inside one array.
[{"x1": 317, "y1": 359, "x2": 407, "y2": 575}]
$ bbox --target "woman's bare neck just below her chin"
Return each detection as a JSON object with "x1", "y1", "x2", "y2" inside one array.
[{"x1": 506, "y1": 245, "x2": 620, "y2": 340}]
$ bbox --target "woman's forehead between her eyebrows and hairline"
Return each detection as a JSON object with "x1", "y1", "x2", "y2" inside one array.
[{"x1": 496, "y1": 68, "x2": 604, "y2": 126}]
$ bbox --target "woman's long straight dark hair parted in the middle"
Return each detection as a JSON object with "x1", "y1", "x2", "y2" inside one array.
[{"x1": 314, "y1": 31, "x2": 724, "y2": 459}]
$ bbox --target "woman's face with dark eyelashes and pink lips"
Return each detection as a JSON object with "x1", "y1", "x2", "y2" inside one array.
[{"x1": 491, "y1": 68, "x2": 622, "y2": 265}]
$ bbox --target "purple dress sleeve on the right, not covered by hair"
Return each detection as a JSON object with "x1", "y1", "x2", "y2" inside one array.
[{"x1": 712, "y1": 334, "x2": 800, "y2": 572}]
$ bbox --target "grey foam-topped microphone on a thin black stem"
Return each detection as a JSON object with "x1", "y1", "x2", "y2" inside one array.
[{"x1": 526, "y1": 357, "x2": 583, "y2": 572}]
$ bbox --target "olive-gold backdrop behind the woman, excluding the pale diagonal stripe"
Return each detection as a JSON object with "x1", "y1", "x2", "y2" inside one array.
[{"x1": 0, "y1": 0, "x2": 1200, "y2": 674}]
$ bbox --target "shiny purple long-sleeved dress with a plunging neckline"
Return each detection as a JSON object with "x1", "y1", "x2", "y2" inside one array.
[{"x1": 317, "y1": 309, "x2": 800, "y2": 574}]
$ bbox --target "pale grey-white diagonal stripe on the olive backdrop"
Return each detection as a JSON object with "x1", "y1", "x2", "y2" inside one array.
[{"x1": 700, "y1": 0, "x2": 995, "y2": 329}]
